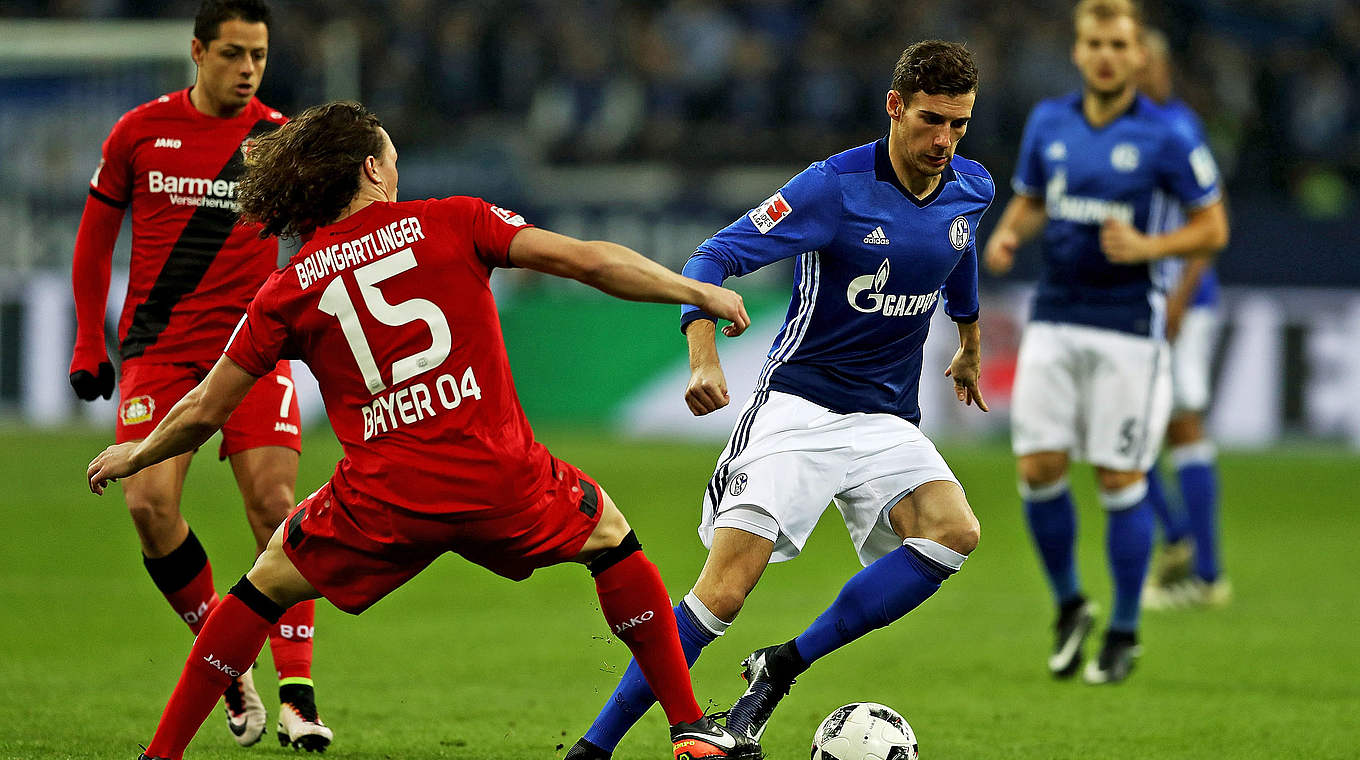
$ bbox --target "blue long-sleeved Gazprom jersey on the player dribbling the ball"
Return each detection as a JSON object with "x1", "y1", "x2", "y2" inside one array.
[{"x1": 681, "y1": 140, "x2": 996, "y2": 423}]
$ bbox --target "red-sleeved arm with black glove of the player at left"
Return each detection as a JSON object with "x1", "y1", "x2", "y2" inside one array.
[{"x1": 69, "y1": 194, "x2": 122, "y2": 401}]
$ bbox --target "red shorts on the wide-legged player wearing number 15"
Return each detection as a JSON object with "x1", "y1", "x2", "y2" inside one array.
[{"x1": 283, "y1": 458, "x2": 601, "y2": 615}]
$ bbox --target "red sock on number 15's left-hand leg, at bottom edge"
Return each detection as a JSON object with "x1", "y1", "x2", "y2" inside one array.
[{"x1": 147, "y1": 579, "x2": 277, "y2": 760}]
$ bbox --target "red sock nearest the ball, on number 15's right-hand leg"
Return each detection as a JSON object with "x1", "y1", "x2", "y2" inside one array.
[{"x1": 596, "y1": 551, "x2": 703, "y2": 726}]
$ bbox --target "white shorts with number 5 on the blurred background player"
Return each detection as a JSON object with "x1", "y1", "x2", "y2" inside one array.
[{"x1": 1010, "y1": 322, "x2": 1171, "y2": 472}]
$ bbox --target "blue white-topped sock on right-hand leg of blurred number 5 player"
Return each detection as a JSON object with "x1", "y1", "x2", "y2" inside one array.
[{"x1": 1102, "y1": 481, "x2": 1156, "y2": 634}]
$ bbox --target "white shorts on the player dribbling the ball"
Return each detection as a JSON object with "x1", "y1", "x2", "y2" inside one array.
[{"x1": 699, "y1": 392, "x2": 959, "y2": 566}]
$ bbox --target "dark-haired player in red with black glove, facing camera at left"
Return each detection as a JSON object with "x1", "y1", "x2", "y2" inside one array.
[{"x1": 71, "y1": 0, "x2": 332, "y2": 749}]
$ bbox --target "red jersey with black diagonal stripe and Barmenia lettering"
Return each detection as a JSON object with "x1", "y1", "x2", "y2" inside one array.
[{"x1": 90, "y1": 90, "x2": 286, "y2": 362}]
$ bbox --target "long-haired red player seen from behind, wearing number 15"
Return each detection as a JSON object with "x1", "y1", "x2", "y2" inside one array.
[{"x1": 87, "y1": 102, "x2": 760, "y2": 760}]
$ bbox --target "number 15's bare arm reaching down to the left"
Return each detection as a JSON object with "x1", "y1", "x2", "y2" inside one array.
[{"x1": 86, "y1": 356, "x2": 258, "y2": 494}]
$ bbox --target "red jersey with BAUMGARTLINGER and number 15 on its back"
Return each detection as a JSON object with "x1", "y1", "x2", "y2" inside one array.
[{"x1": 226, "y1": 197, "x2": 552, "y2": 514}]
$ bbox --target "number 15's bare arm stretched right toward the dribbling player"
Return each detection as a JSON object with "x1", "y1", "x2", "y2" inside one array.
[{"x1": 510, "y1": 228, "x2": 751, "y2": 337}]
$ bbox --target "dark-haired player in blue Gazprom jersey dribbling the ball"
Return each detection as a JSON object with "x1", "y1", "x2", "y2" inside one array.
[{"x1": 567, "y1": 41, "x2": 994, "y2": 760}]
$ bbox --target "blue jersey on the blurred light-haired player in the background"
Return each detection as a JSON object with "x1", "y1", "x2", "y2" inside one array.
[{"x1": 1013, "y1": 92, "x2": 1219, "y2": 337}]
